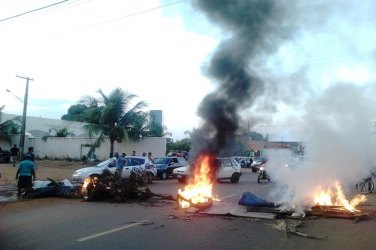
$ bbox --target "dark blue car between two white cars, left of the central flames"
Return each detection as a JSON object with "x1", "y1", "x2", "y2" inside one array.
[{"x1": 153, "y1": 156, "x2": 189, "y2": 180}]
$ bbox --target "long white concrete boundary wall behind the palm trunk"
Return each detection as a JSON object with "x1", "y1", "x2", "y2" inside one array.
[{"x1": 15, "y1": 137, "x2": 166, "y2": 160}]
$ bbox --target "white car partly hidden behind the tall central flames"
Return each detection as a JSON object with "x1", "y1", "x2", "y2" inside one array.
[{"x1": 173, "y1": 157, "x2": 242, "y2": 183}]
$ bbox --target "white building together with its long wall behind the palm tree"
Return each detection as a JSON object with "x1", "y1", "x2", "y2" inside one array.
[{"x1": 0, "y1": 113, "x2": 166, "y2": 160}]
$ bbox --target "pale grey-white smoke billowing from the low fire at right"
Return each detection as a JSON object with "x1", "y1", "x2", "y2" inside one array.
[{"x1": 267, "y1": 83, "x2": 376, "y2": 208}]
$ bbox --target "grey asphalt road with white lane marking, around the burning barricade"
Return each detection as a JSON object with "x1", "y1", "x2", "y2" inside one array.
[{"x1": 0, "y1": 170, "x2": 376, "y2": 249}]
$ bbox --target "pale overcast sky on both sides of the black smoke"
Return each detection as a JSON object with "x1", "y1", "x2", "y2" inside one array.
[{"x1": 0, "y1": 0, "x2": 376, "y2": 140}]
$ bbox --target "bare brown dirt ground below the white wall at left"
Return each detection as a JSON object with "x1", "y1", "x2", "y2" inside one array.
[{"x1": 0, "y1": 160, "x2": 85, "y2": 186}]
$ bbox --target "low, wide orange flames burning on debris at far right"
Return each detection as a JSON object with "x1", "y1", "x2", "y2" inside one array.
[{"x1": 314, "y1": 182, "x2": 367, "y2": 212}]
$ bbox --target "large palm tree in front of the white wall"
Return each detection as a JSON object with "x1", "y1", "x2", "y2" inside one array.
[{"x1": 81, "y1": 88, "x2": 147, "y2": 157}]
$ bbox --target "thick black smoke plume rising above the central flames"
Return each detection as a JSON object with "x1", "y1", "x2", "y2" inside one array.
[{"x1": 193, "y1": 0, "x2": 296, "y2": 156}]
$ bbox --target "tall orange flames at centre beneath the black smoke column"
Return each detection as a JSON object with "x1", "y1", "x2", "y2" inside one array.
[{"x1": 178, "y1": 155, "x2": 218, "y2": 208}]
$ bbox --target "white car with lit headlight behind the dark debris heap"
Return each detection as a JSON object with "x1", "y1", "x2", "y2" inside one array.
[{"x1": 72, "y1": 156, "x2": 157, "y2": 182}]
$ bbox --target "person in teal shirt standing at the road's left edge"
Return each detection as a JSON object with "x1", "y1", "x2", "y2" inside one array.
[{"x1": 16, "y1": 154, "x2": 35, "y2": 198}]
